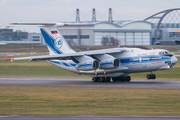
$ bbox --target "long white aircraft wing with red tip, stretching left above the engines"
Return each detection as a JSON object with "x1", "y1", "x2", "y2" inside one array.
[{"x1": 4, "y1": 48, "x2": 126, "y2": 61}]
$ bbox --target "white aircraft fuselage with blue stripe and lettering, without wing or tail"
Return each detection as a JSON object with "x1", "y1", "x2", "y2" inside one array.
[{"x1": 49, "y1": 48, "x2": 177, "y2": 77}]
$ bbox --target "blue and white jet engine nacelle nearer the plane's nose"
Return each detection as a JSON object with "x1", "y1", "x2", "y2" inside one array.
[{"x1": 99, "y1": 59, "x2": 120, "y2": 69}]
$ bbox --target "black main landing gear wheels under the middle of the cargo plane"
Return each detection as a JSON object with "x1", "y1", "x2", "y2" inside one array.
[{"x1": 92, "y1": 76, "x2": 131, "y2": 82}]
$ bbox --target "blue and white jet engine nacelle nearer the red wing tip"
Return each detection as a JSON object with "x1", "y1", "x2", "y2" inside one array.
[{"x1": 76, "y1": 60, "x2": 99, "y2": 71}]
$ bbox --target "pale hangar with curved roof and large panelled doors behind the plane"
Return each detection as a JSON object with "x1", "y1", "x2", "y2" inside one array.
[{"x1": 59, "y1": 21, "x2": 152, "y2": 46}]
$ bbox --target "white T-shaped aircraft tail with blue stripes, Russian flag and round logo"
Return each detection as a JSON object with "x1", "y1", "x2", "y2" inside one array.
[{"x1": 11, "y1": 23, "x2": 75, "y2": 55}]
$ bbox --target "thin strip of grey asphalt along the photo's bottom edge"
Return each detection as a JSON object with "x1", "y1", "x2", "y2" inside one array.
[{"x1": 0, "y1": 116, "x2": 180, "y2": 120}]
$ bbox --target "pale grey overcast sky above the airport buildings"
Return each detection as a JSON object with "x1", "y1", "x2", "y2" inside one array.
[{"x1": 0, "y1": 0, "x2": 180, "y2": 32}]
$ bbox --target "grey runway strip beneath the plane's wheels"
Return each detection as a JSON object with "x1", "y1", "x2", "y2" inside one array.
[{"x1": 0, "y1": 78, "x2": 180, "y2": 89}]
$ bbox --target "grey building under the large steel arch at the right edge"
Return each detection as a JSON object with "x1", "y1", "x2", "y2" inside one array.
[{"x1": 144, "y1": 8, "x2": 180, "y2": 45}]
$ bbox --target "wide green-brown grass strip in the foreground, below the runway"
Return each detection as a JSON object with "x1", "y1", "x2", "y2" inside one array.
[{"x1": 0, "y1": 86, "x2": 180, "y2": 116}]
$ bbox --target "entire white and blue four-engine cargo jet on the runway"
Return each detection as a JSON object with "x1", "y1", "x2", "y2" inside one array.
[{"x1": 5, "y1": 23, "x2": 178, "y2": 82}]
